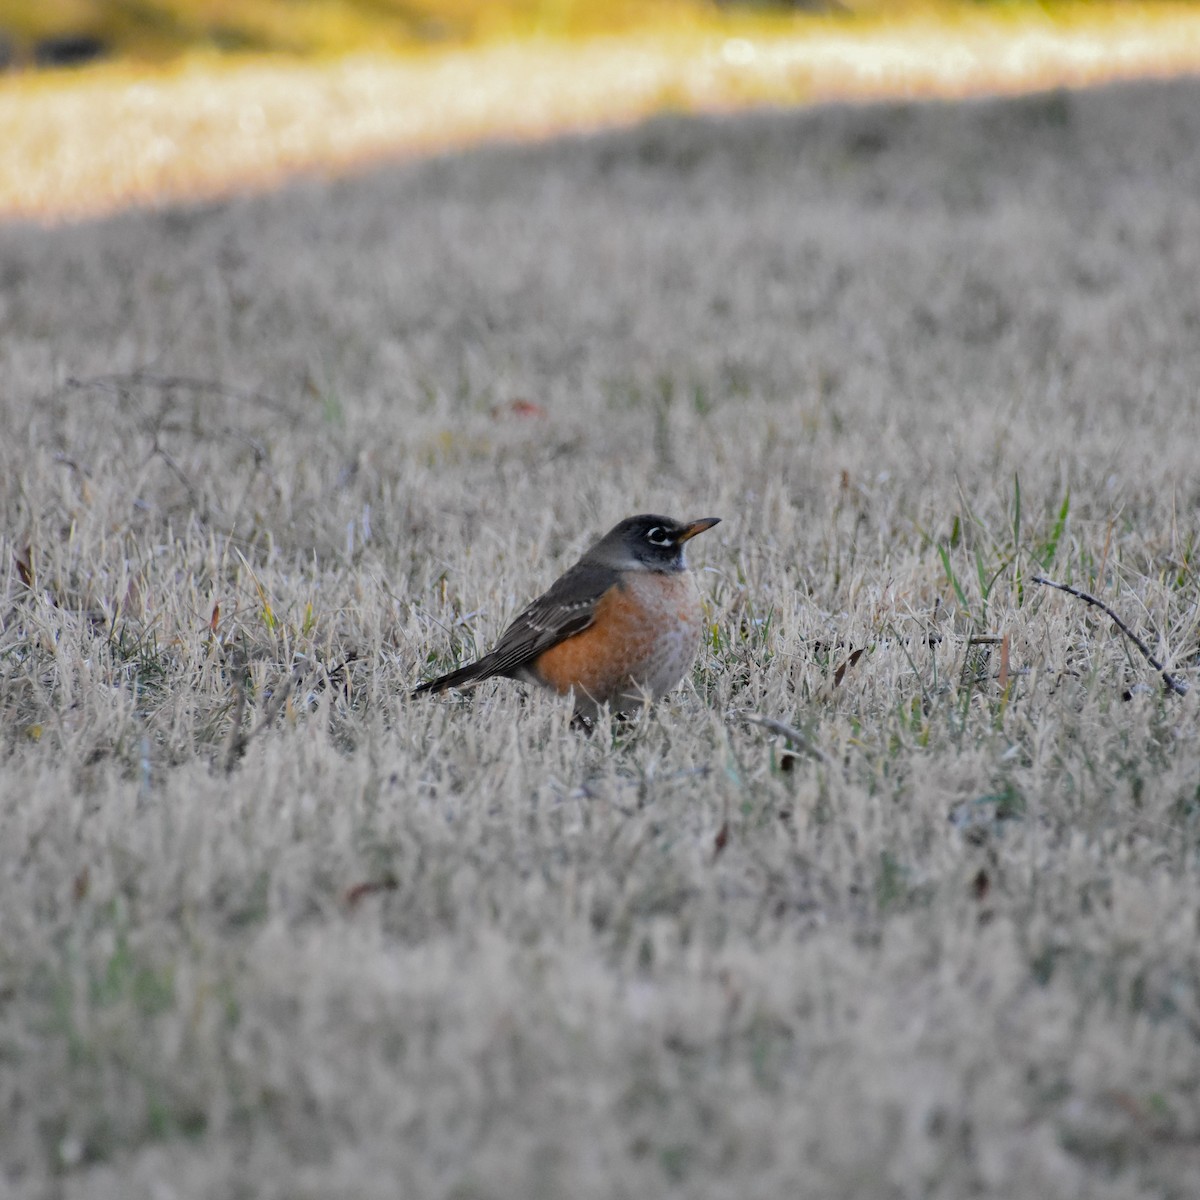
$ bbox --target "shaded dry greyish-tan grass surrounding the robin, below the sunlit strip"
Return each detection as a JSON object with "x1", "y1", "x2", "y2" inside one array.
[{"x1": 7, "y1": 72, "x2": 1200, "y2": 1200}]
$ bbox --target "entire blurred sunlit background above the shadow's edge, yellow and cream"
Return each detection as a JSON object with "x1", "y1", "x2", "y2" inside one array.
[{"x1": 0, "y1": 0, "x2": 1200, "y2": 221}]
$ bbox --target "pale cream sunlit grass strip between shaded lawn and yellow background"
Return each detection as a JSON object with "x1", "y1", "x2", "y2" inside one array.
[{"x1": 7, "y1": 6, "x2": 1200, "y2": 218}]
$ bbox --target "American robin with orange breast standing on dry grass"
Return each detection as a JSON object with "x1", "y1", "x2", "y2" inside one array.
[{"x1": 413, "y1": 514, "x2": 720, "y2": 719}]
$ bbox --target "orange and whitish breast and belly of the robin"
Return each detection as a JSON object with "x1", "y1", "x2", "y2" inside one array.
[{"x1": 533, "y1": 571, "x2": 703, "y2": 708}]
